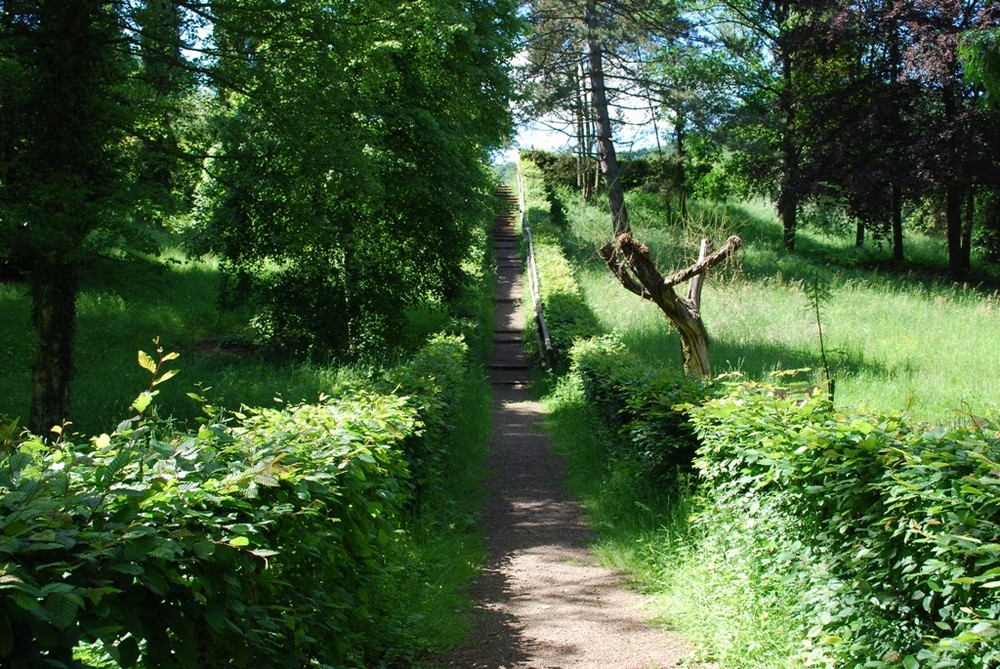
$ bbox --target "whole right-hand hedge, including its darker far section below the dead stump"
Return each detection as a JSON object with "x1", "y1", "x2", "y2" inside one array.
[{"x1": 571, "y1": 328, "x2": 1000, "y2": 669}]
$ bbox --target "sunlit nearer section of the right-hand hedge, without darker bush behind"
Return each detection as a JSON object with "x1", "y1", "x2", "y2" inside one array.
[{"x1": 688, "y1": 384, "x2": 1000, "y2": 669}]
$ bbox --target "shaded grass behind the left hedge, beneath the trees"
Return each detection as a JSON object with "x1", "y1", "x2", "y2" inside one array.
[{"x1": 0, "y1": 243, "x2": 489, "y2": 434}]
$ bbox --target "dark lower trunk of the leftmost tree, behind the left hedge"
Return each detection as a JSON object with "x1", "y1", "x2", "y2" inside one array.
[{"x1": 28, "y1": 264, "x2": 79, "y2": 436}]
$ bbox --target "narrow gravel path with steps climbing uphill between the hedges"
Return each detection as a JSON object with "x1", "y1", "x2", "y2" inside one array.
[{"x1": 441, "y1": 189, "x2": 687, "y2": 669}]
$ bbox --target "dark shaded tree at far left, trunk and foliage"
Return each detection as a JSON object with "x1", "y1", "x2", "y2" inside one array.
[{"x1": 0, "y1": 0, "x2": 131, "y2": 434}]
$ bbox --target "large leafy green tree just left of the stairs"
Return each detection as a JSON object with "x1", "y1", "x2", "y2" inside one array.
[{"x1": 203, "y1": 0, "x2": 517, "y2": 352}]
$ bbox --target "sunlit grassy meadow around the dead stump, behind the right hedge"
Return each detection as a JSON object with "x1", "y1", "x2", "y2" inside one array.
[{"x1": 561, "y1": 191, "x2": 1000, "y2": 422}]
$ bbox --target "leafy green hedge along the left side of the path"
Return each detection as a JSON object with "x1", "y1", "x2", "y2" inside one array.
[{"x1": 0, "y1": 337, "x2": 466, "y2": 669}]
